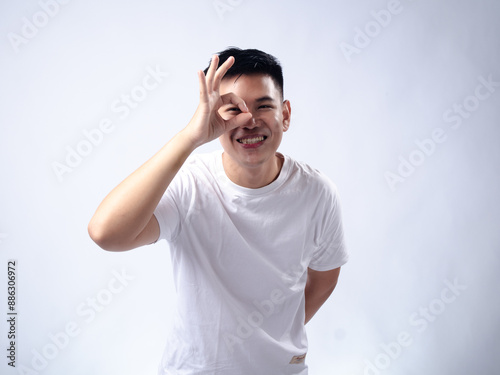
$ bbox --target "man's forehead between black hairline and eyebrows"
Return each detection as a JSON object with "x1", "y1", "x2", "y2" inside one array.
[{"x1": 220, "y1": 74, "x2": 280, "y2": 101}]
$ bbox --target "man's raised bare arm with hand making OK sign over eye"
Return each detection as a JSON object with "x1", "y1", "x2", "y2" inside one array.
[{"x1": 88, "y1": 56, "x2": 251, "y2": 251}]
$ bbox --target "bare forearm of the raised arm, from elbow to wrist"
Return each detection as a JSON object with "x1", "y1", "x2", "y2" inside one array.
[{"x1": 88, "y1": 131, "x2": 195, "y2": 249}]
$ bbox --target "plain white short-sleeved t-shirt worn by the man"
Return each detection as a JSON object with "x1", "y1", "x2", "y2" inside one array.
[{"x1": 154, "y1": 151, "x2": 348, "y2": 375}]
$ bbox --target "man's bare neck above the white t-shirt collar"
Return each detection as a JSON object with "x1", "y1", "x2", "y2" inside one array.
[{"x1": 222, "y1": 153, "x2": 284, "y2": 189}]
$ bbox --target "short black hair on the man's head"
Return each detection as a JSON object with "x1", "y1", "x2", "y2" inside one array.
[{"x1": 204, "y1": 47, "x2": 283, "y2": 98}]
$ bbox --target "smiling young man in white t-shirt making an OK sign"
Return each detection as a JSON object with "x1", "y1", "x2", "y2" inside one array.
[{"x1": 89, "y1": 48, "x2": 347, "y2": 375}]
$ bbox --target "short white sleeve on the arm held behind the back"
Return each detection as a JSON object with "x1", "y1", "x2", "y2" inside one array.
[{"x1": 309, "y1": 180, "x2": 349, "y2": 271}]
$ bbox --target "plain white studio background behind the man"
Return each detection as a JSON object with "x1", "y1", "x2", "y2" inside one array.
[{"x1": 0, "y1": 0, "x2": 500, "y2": 375}]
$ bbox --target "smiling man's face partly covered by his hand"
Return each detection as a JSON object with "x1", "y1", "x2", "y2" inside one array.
[{"x1": 219, "y1": 74, "x2": 290, "y2": 172}]
